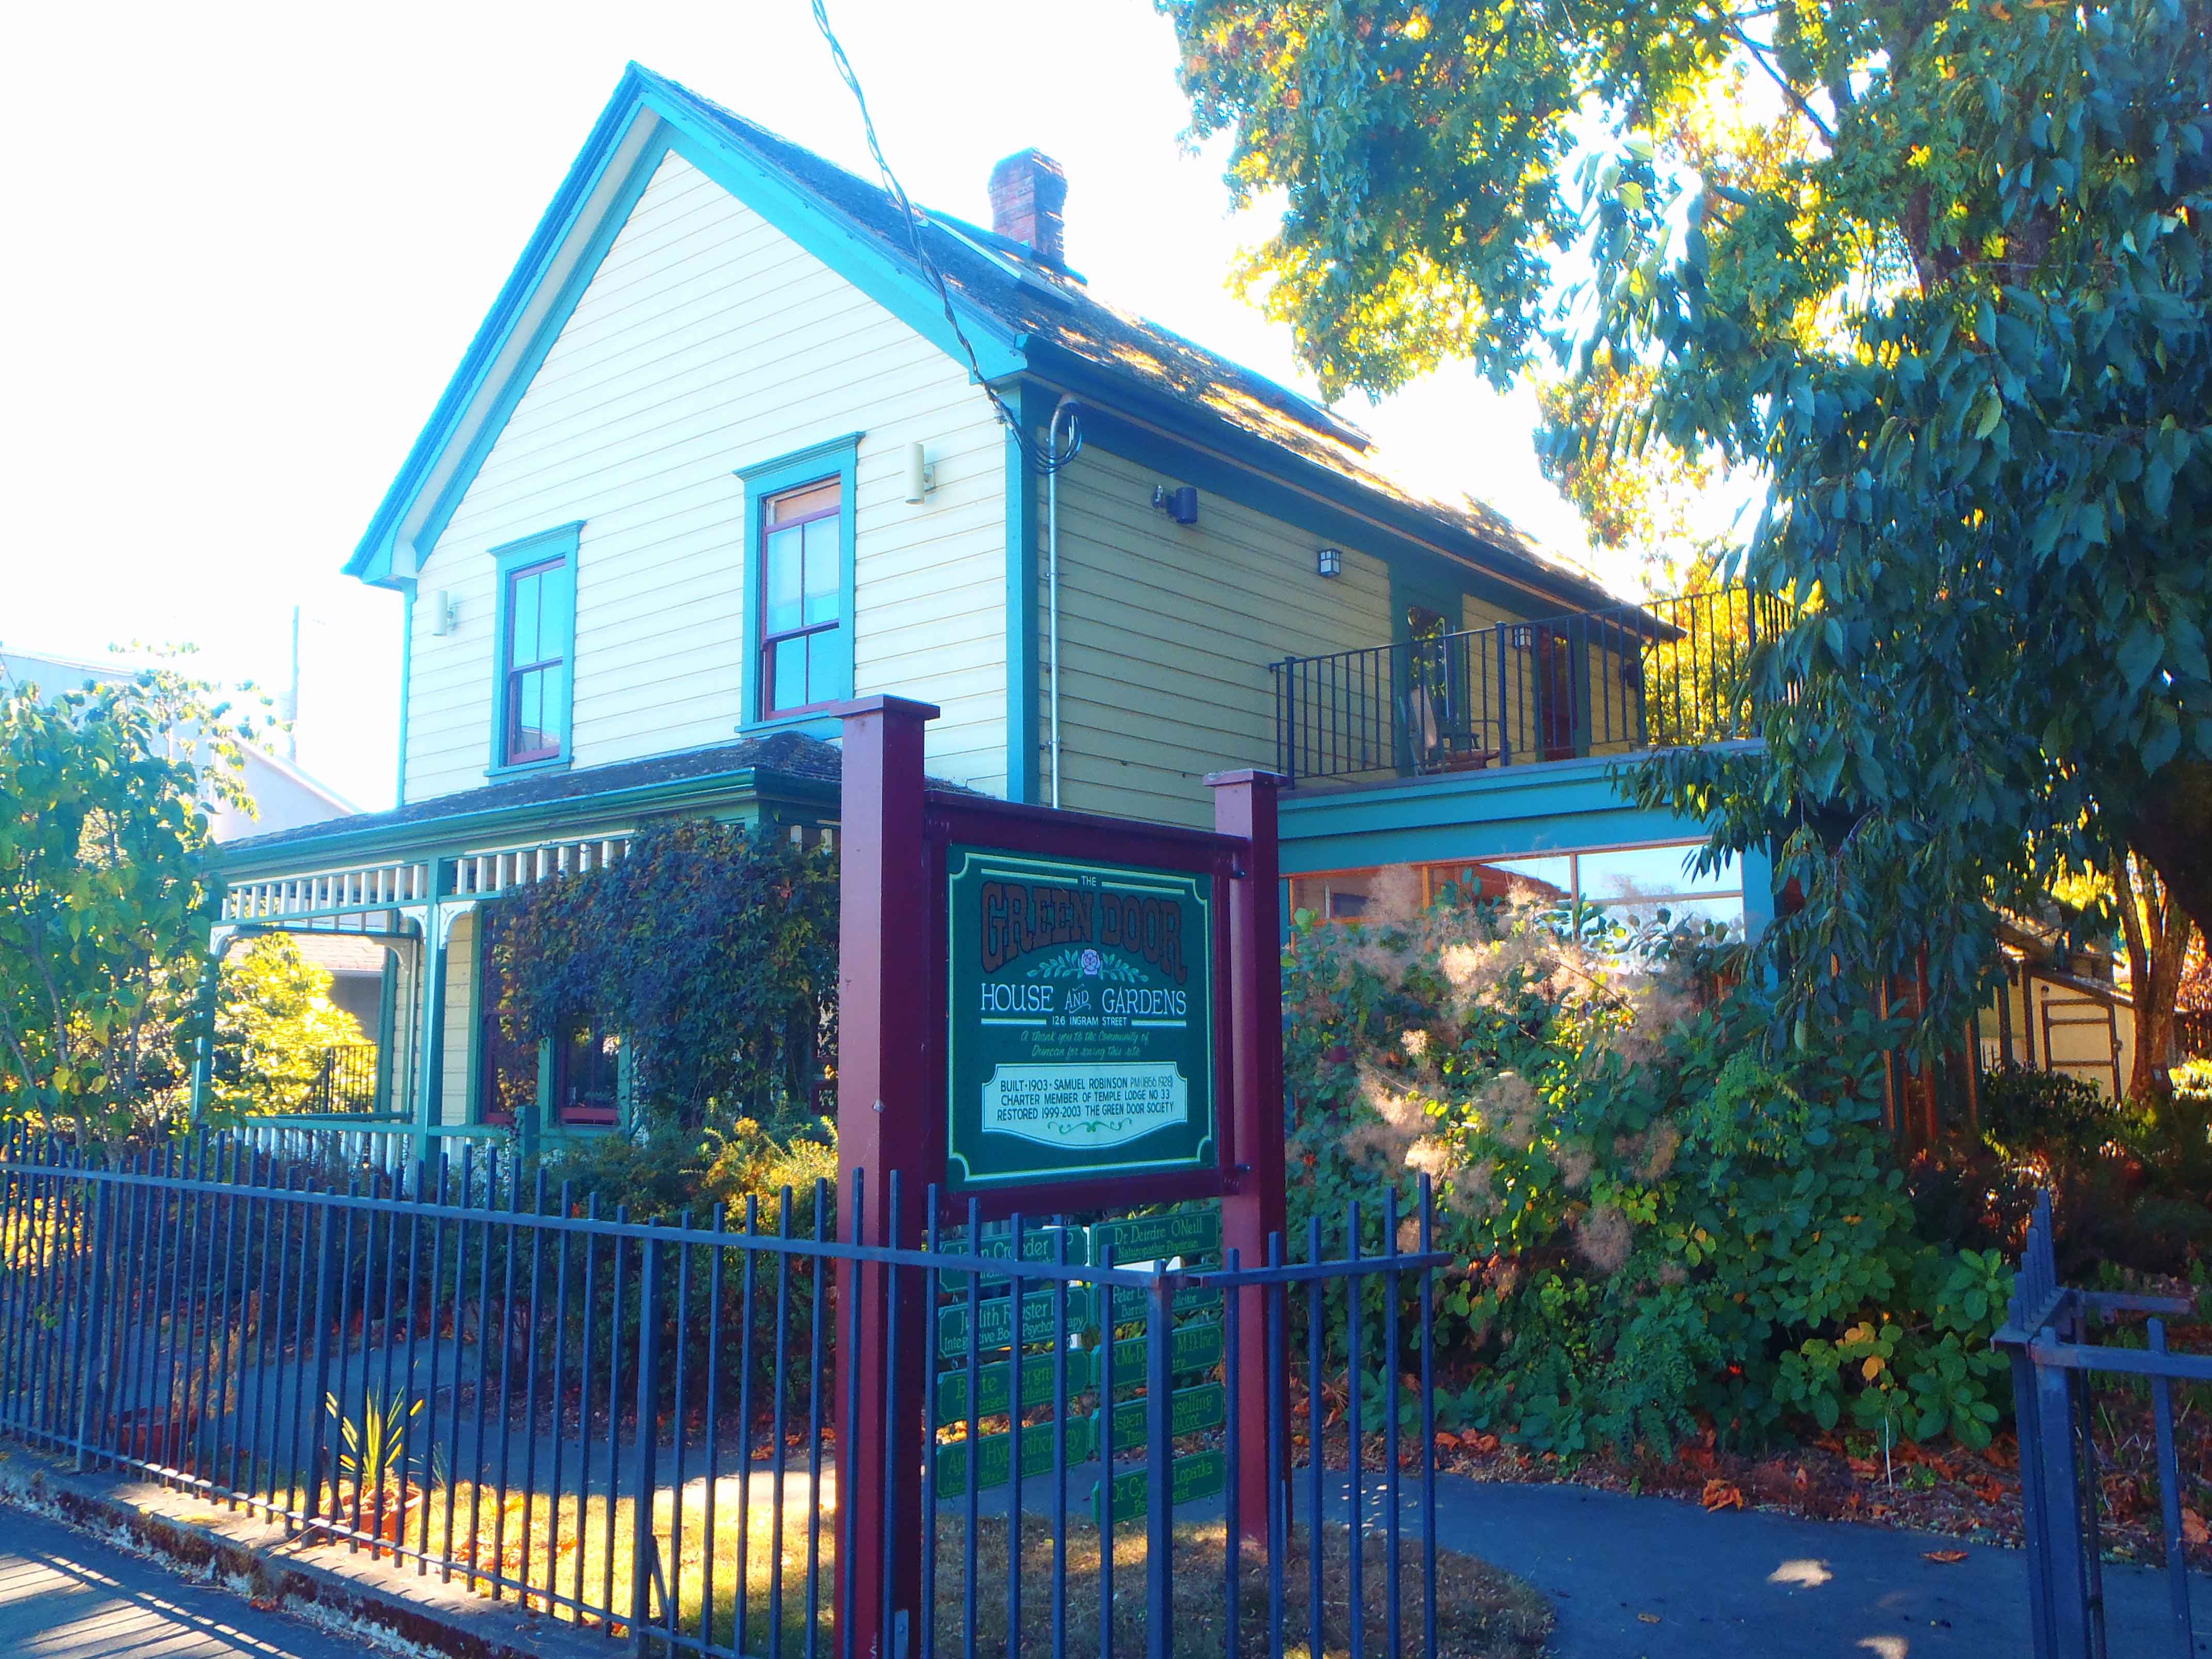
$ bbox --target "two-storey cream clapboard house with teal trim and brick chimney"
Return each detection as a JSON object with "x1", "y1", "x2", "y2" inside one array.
[{"x1": 223, "y1": 64, "x2": 1772, "y2": 1137}]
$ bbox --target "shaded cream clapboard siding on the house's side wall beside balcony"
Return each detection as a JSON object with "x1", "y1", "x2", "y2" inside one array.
[{"x1": 1037, "y1": 447, "x2": 1391, "y2": 825}]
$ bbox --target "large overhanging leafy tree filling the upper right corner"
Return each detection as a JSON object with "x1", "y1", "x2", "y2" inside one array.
[{"x1": 1163, "y1": 0, "x2": 2212, "y2": 1042}]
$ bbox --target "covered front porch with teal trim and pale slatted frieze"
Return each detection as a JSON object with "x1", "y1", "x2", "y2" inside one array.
[{"x1": 192, "y1": 735, "x2": 836, "y2": 1168}]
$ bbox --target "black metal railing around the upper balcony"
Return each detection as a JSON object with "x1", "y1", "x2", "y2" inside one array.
[{"x1": 1272, "y1": 589, "x2": 1787, "y2": 783}]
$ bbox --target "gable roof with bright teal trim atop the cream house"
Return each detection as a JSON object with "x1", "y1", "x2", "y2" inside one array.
[{"x1": 345, "y1": 64, "x2": 1615, "y2": 606}]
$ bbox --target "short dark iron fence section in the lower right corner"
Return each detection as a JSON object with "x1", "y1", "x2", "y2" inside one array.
[{"x1": 1995, "y1": 1192, "x2": 2212, "y2": 1659}]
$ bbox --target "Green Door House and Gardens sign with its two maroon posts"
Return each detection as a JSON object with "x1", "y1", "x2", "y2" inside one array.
[{"x1": 836, "y1": 697, "x2": 1285, "y2": 1659}]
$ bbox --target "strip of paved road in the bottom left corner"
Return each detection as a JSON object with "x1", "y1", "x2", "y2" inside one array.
[{"x1": 0, "y1": 1508, "x2": 363, "y2": 1659}]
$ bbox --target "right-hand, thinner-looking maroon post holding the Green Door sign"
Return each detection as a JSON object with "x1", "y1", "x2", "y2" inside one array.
[{"x1": 1206, "y1": 772, "x2": 1292, "y2": 1539}]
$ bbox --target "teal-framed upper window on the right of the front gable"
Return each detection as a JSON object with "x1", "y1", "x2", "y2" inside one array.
[{"x1": 737, "y1": 431, "x2": 860, "y2": 730}]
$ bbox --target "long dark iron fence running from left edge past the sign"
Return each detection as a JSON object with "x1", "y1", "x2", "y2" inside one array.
[{"x1": 0, "y1": 1130, "x2": 1446, "y2": 1659}]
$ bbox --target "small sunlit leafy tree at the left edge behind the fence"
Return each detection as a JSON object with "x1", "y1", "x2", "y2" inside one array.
[{"x1": 0, "y1": 668, "x2": 250, "y2": 1144}]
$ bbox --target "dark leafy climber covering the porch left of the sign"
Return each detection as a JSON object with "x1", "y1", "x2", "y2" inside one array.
[{"x1": 491, "y1": 819, "x2": 838, "y2": 1130}]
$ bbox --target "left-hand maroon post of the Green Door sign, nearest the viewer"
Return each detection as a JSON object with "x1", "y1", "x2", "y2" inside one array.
[{"x1": 836, "y1": 697, "x2": 945, "y2": 1659}]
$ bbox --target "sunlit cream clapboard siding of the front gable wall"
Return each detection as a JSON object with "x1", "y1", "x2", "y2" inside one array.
[{"x1": 405, "y1": 155, "x2": 1006, "y2": 805}]
